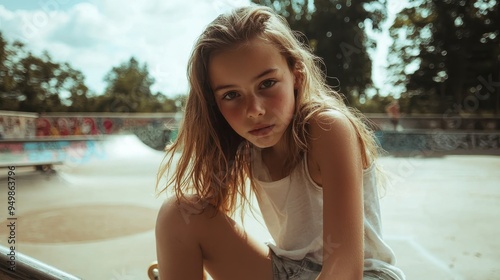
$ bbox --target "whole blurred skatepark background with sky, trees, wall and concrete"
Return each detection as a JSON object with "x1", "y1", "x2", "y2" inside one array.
[{"x1": 0, "y1": 0, "x2": 500, "y2": 279}]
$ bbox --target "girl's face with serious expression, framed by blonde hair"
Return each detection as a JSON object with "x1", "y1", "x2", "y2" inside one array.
[{"x1": 208, "y1": 38, "x2": 298, "y2": 148}]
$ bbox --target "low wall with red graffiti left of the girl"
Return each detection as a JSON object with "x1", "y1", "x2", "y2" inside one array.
[{"x1": 0, "y1": 111, "x2": 181, "y2": 155}]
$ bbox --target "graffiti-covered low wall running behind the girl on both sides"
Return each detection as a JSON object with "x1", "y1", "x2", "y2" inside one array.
[{"x1": 0, "y1": 111, "x2": 500, "y2": 161}]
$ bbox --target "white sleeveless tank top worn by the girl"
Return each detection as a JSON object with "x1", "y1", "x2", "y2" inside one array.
[{"x1": 252, "y1": 148, "x2": 405, "y2": 279}]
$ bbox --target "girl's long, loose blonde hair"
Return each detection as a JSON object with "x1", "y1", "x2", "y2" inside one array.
[{"x1": 157, "y1": 6, "x2": 377, "y2": 217}]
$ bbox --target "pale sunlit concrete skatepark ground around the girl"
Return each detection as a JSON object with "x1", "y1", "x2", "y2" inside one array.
[{"x1": 0, "y1": 136, "x2": 500, "y2": 280}]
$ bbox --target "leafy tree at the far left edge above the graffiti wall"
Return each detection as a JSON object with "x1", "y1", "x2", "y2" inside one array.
[{"x1": 0, "y1": 34, "x2": 92, "y2": 113}]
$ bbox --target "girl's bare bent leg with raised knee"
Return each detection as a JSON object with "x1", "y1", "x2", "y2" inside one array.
[{"x1": 156, "y1": 199, "x2": 272, "y2": 280}]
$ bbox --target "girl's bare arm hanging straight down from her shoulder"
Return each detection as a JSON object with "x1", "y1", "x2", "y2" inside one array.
[{"x1": 310, "y1": 111, "x2": 364, "y2": 280}]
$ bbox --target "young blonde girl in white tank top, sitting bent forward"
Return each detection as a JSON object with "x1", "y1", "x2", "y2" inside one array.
[{"x1": 156, "y1": 6, "x2": 404, "y2": 280}]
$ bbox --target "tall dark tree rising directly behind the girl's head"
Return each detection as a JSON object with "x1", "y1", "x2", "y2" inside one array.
[{"x1": 254, "y1": 0, "x2": 386, "y2": 105}]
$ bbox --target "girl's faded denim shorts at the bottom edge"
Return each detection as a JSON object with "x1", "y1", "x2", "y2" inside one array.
[{"x1": 270, "y1": 250, "x2": 395, "y2": 280}]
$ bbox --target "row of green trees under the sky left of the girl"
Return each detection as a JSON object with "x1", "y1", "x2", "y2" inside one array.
[{"x1": 0, "y1": 33, "x2": 182, "y2": 113}]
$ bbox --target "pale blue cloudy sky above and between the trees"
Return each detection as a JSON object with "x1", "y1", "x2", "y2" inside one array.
[{"x1": 0, "y1": 0, "x2": 403, "y2": 96}]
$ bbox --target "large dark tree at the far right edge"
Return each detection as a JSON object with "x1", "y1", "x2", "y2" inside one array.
[{"x1": 390, "y1": 0, "x2": 500, "y2": 114}]
